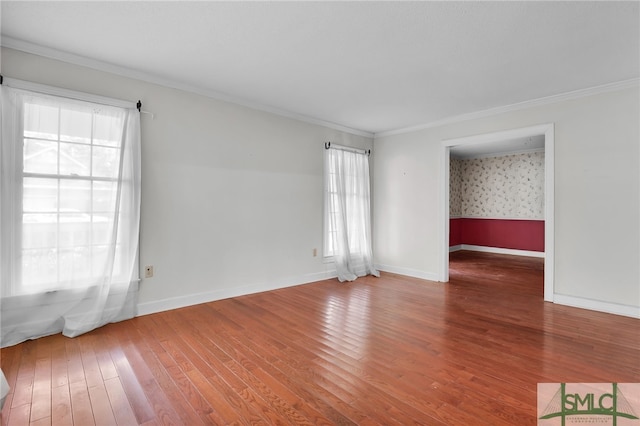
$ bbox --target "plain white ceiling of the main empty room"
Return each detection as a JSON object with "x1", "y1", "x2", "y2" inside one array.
[{"x1": 0, "y1": 0, "x2": 640, "y2": 134}]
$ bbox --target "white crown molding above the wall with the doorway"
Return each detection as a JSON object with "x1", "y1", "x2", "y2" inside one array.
[{"x1": 374, "y1": 78, "x2": 640, "y2": 138}]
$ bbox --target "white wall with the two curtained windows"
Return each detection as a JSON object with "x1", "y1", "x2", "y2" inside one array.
[{"x1": 1, "y1": 48, "x2": 373, "y2": 313}]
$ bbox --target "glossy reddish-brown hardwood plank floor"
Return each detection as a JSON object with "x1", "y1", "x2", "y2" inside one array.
[{"x1": 1, "y1": 252, "x2": 640, "y2": 426}]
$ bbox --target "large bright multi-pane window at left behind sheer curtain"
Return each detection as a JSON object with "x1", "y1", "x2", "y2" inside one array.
[{"x1": 3, "y1": 88, "x2": 140, "y2": 295}]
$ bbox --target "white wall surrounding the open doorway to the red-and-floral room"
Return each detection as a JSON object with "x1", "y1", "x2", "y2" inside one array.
[{"x1": 373, "y1": 87, "x2": 640, "y2": 317}]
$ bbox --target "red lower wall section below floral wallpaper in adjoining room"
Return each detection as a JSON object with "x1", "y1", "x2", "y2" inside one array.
[{"x1": 449, "y1": 218, "x2": 544, "y2": 252}]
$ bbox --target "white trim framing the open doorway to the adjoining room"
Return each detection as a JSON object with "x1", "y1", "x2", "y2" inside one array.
[{"x1": 439, "y1": 123, "x2": 555, "y2": 302}]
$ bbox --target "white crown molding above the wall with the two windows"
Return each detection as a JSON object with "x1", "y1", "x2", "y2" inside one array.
[{"x1": 0, "y1": 35, "x2": 374, "y2": 138}]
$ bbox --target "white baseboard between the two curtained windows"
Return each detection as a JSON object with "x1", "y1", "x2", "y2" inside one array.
[{"x1": 137, "y1": 271, "x2": 337, "y2": 316}]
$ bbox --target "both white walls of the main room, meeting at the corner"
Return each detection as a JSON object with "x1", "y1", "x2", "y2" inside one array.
[{"x1": 1, "y1": 48, "x2": 640, "y2": 316}]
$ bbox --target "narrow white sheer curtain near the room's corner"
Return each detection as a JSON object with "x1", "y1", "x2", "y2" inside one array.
[{"x1": 325, "y1": 147, "x2": 380, "y2": 282}]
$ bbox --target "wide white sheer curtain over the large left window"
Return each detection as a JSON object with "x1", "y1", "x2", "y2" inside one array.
[{"x1": 0, "y1": 85, "x2": 140, "y2": 347}]
